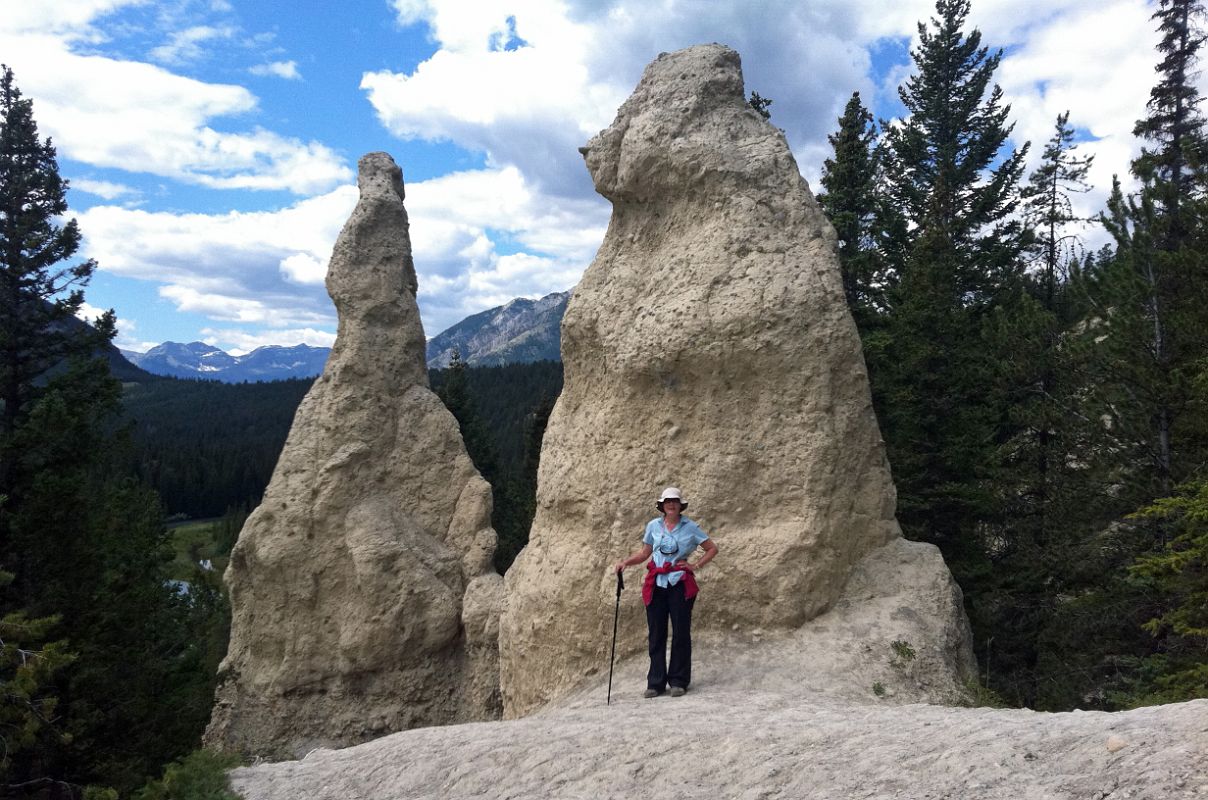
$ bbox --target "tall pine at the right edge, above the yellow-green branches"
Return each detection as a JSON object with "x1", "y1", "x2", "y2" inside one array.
[{"x1": 1092, "y1": 0, "x2": 1208, "y2": 503}]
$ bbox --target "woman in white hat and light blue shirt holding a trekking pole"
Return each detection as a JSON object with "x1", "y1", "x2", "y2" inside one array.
[{"x1": 616, "y1": 486, "x2": 718, "y2": 697}]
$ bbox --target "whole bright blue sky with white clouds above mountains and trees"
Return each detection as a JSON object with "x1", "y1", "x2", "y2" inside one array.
[{"x1": 0, "y1": 0, "x2": 1156, "y2": 352}]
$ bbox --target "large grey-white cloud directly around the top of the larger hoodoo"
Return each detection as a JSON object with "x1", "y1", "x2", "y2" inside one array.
[{"x1": 361, "y1": 0, "x2": 869, "y2": 197}]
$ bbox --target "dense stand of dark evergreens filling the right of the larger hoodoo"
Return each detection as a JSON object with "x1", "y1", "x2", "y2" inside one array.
[{"x1": 819, "y1": 0, "x2": 1208, "y2": 709}]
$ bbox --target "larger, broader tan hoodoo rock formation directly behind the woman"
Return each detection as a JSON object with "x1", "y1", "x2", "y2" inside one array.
[{"x1": 500, "y1": 45, "x2": 971, "y2": 717}]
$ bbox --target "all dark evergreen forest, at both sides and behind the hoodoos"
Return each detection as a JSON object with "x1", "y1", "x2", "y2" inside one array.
[{"x1": 0, "y1": 0, "x2": 1208, "y2": 800}]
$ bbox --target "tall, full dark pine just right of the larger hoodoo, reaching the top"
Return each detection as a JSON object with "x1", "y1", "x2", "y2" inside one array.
[{"x1": 870, "y1": 0, "x2": 1028, "y2": 555}]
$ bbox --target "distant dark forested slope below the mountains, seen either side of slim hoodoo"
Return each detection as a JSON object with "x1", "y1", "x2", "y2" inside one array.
[{"x1": 122, "y1": 361, "x2": 562, "y2": 567}]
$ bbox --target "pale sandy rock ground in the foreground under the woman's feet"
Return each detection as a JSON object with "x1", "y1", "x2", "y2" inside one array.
[{"x1": 232, "y1": 645, "x2": 1208, "y2": 800}]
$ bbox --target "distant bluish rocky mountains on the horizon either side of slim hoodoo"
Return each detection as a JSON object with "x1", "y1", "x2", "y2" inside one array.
[{"x1": 121, "y1": 291, "x2": 570, "y2": 383}]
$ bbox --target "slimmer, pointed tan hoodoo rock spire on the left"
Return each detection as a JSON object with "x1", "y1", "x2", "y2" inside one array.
[{"x1": 205, "y1": 152, "x2": 503, "y2": 758}]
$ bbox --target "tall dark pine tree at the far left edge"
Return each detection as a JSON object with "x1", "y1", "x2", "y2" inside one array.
[{"x1": 0, "y1": 68, "x2": 213, "y2": 794}]
